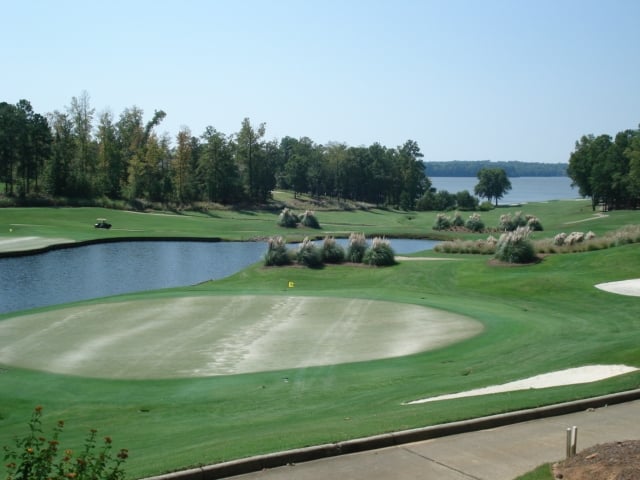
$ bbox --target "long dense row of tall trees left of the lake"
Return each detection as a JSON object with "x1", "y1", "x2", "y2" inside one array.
[{"x1": 0, "y1": 92, "x2": 430, "y2": 209}]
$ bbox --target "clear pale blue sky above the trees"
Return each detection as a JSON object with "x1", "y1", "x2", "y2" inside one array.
[{"x1": 0, "y1": 0, "x2": 640, "y2": 163}]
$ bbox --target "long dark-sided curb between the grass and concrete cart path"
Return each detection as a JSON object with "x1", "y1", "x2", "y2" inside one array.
[{"x1": 142, "y1": 389, "x2": 640, "y2": 480}]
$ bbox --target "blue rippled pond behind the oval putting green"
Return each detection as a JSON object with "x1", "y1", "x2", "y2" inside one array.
[{"x1": 0, "y1": 239, "x2": 437, "y2": 313}]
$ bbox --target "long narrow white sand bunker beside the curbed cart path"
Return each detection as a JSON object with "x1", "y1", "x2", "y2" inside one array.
[{"x1": 407, "y1": 365, "x2": 638, "y2": 405}]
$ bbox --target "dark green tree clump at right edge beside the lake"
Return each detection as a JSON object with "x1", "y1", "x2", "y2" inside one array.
[{"x1": 567, "y1": 126, "x2": 640, "y2": 210}]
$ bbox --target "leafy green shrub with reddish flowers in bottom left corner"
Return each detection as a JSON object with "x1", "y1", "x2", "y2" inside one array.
[{"x1": 4, "y1": 407, "x2": 129, "y2": 480}]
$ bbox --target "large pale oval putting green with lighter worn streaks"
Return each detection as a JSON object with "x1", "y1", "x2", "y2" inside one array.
[{"x1": 0, "y1": 295, "x2": 482, "y2": 379}]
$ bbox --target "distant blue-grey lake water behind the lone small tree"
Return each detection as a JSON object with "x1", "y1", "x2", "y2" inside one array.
[{"x1": 429, "y1": 177, "x2": 580, "y2": 204}]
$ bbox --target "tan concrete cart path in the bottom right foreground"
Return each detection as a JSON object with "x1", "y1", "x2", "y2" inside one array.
[{"x1": 232, "y1": 400, "x2": 640, "y2": 480}]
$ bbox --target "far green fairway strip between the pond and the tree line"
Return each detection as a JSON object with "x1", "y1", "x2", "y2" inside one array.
[{"x1": 0, "y1": 201, "x2": 638, "y2": 241}]
